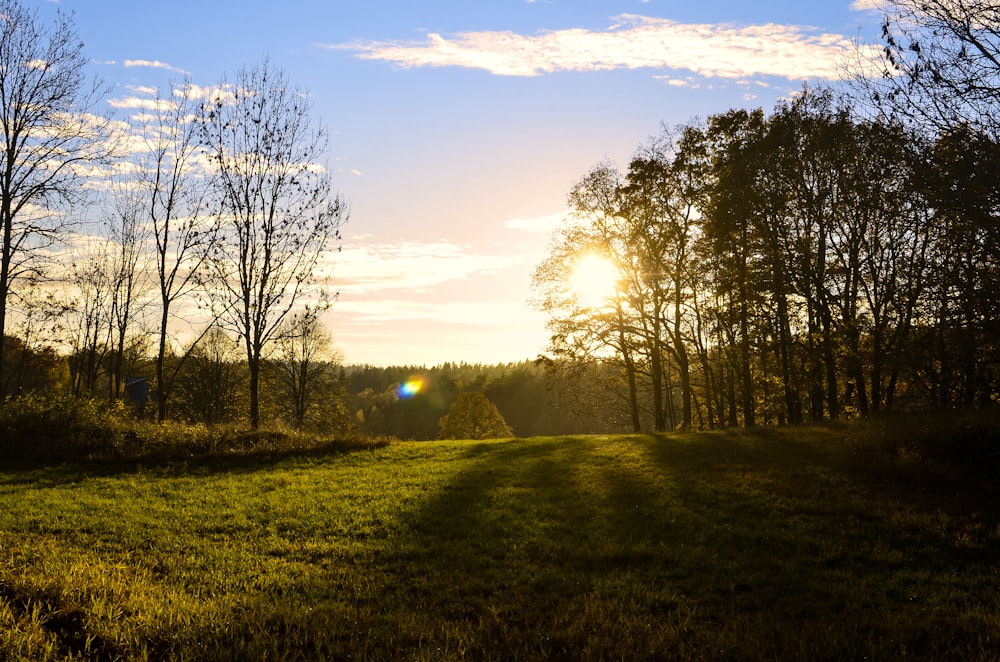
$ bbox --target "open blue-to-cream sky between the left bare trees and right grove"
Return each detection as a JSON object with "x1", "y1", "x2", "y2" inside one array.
[{"x1": 37, "y1": 0, "x2": 879, "y2": 365}]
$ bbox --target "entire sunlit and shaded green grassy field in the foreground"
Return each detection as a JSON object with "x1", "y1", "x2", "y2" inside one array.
[{"x1": 0, "y1": 428, "x2": 1000, "y2": 660}]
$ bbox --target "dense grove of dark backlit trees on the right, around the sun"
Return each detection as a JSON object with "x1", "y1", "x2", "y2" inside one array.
[{"x1": 533, "y1": 0, "x2": 1000, "y2": 431}]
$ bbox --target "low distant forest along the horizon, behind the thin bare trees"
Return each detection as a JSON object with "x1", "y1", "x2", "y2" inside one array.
[{"x1": 0, "y1": 344, "x2": 628, "y2": 440}]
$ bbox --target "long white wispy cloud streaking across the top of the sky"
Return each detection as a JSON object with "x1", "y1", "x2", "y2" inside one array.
[{"x1": 326, "y1": 13, "x2": 876, "y2": 80}]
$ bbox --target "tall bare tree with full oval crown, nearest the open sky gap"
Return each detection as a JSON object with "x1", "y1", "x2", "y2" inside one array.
[{"x1": 201, "y1": 59, "x2": 347, "y2": 428}]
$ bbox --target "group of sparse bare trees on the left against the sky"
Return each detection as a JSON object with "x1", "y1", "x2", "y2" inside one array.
[{"x1": 0, "y1": 0, "x2": 348, "y2": 428}]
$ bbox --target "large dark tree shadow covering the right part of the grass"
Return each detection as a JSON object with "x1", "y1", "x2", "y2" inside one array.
[{"x1": 372, "y1": 428, "x2": 1000, "y2": 659}]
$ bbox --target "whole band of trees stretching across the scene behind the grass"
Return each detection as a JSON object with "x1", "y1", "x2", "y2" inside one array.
[{"x1": 0, "y1": 0, "x2": 1000, "y2": 438}]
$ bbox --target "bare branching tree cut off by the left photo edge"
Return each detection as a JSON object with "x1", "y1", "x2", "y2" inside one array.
[{"x1": 0, "y1": 0, "x2": 108, "y2": 394}]
